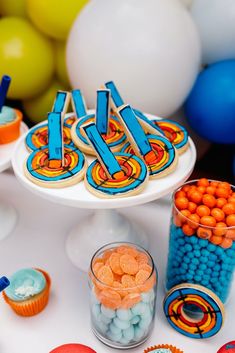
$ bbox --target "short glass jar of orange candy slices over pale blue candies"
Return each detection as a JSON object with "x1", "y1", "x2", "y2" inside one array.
[{"x1": 89, "y1": 243, "x2": 157, "y2": 349}]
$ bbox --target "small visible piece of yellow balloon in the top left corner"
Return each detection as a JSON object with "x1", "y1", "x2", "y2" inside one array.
[{"x1": 0, "y1": 0, "x2": 27, "y2": 17}]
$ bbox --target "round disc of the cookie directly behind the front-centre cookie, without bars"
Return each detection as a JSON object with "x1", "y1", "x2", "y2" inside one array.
[{"x1": 71, "y1": 114, "x2": 126, "y2": 155}]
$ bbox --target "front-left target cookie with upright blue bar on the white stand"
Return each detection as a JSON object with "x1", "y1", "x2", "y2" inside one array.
[{"x1": 24, "y1": 113, "x2": 86, "y2": 188}]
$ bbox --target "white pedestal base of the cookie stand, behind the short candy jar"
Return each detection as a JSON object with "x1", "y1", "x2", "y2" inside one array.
[{"x1": 66, "y1": 209, "x2": 148, "y2": 271}]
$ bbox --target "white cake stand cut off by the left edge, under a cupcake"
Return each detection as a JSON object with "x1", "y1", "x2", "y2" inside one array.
[{"x1": 0, "y1": 122, "x2": 28, "y2": 240}]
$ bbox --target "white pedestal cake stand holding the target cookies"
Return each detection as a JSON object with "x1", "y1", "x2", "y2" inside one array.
[{"x1": 12, "y1": 115, "x2": 196, "y2": 271}]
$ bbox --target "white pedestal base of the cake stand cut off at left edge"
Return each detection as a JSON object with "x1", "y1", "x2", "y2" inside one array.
[{"x1": 0, "y1": 201, "x2": 17, "y2": 240}]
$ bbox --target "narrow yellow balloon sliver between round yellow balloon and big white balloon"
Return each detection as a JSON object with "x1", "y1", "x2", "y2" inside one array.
[{"x1": 55, "y1": 41, "x2": 70, "y2": 88}]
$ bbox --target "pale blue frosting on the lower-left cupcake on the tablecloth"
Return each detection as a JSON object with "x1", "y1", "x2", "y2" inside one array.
[{"x1": 5, "y1": 268, "x2": 46, "y2": 301}]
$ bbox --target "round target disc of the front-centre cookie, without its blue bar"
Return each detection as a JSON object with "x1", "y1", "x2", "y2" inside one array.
[{"x1": 85, "y1": 153, "x2": 148, "y2": 198}]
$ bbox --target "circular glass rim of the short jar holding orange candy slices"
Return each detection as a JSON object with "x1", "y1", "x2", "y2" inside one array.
[{"x1": 90, "y1": 241, "x2": 158, "y2": 292}]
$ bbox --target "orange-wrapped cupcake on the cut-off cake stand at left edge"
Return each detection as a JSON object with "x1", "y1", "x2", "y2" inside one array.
[{"x1": 0, "y1": 106, "x2": 23, "y2": 145}]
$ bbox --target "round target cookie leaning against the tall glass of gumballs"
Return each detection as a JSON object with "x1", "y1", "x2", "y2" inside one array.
[{"x1": 163, "y1": 283, "x2": 224, "y2": 339}]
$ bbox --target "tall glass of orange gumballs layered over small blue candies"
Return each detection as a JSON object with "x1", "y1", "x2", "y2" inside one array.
[{"x1": 167, "y1": 178, "x2": 235, "y2": 303}]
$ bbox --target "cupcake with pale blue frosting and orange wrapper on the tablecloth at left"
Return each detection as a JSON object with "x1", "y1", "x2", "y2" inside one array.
[{"x1": 3, "y1": 268, "x2": 51, "y2": 316}]
